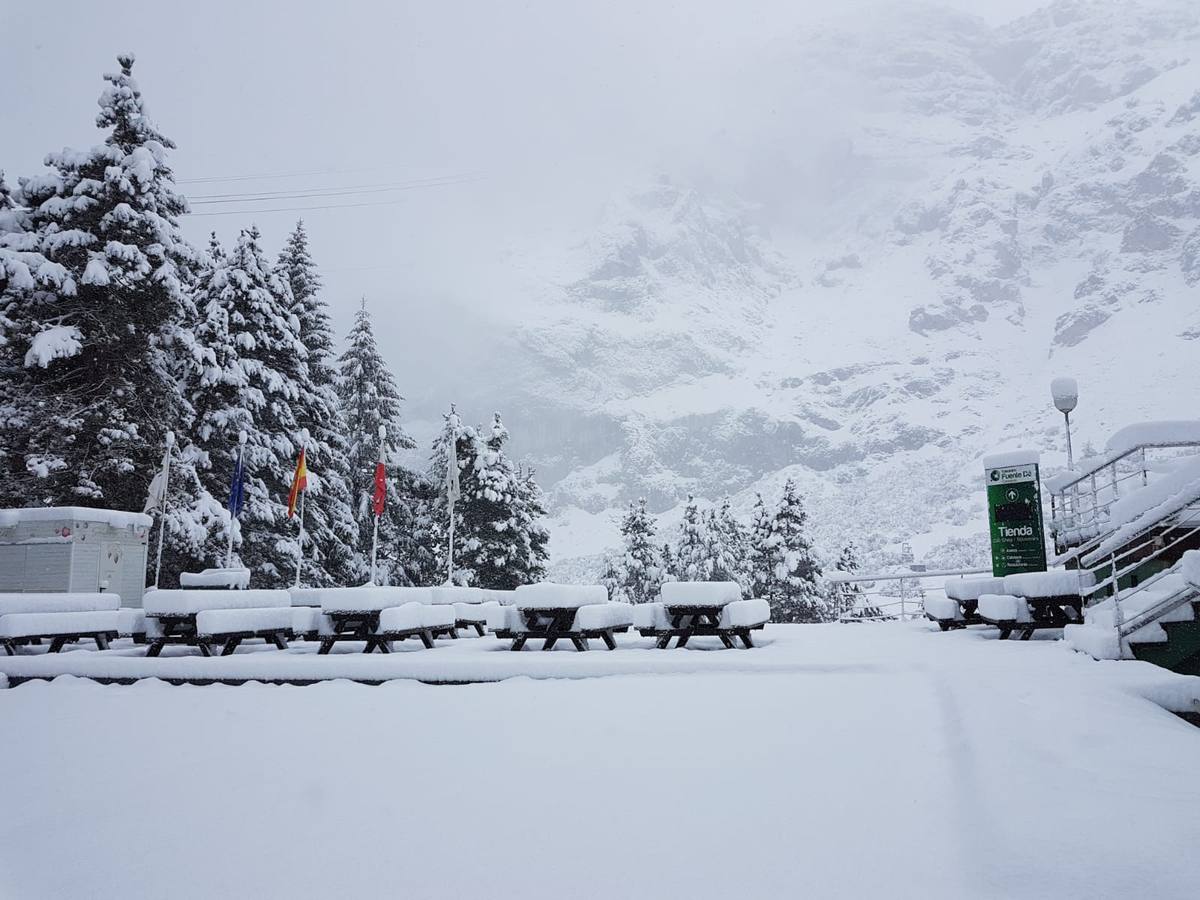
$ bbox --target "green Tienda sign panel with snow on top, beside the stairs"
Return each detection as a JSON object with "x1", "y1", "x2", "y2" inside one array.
[{"x1": 984, "y1": 455, "x2": 1046, "y2": 577}]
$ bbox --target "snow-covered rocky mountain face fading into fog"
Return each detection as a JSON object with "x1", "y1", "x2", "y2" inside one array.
[{"x1": 465, "y1": 0, "x2": 1200, "y2": 565}]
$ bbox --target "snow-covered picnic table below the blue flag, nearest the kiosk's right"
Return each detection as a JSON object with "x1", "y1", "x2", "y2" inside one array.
[{"x1": 142, "y1": 589, "x2": 292, "y2": 656}]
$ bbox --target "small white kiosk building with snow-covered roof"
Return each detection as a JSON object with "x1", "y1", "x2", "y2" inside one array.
[{"x1": 0, "y1": 506, "x2": 152, "y2": 606}]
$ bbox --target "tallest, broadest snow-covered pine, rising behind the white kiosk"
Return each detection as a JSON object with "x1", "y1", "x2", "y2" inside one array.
[{"x1": 0, "y1": 55, "x2": 199, "y2": 509}]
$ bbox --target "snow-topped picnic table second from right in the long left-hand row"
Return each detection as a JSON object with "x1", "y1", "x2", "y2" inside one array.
[{"x1": 493, "y1": 582, "x2": 634, "y2": 650}]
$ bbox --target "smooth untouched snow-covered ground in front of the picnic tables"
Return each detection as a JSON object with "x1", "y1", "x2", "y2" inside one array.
[{"x1": 0, "y1": 623, "x2": 1200, "y2": 900}]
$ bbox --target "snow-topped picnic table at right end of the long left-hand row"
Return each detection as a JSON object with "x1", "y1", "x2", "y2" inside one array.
[{"x1": 635, "y1": 581, "x2": 770, "y2": 649}]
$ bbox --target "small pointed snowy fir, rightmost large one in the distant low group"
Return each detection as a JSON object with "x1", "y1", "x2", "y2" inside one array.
[{"x1": 763, "y1": 479, "x2": 830, "y2": 622}]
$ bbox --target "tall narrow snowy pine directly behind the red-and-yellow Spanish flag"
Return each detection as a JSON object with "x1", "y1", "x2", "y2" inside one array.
[{"x1": 276, "y1": 222, "x2": 357, "y2": 587}]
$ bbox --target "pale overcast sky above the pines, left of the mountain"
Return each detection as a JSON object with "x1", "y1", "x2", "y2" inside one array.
[{"x1": 0, "y1": 0, "x2": 1043, "y2": 420}]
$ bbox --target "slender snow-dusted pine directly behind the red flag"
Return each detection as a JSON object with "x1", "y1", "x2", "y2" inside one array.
[{"x1": 336, "y1": 300, "x2": 440, "y2": 586}]
